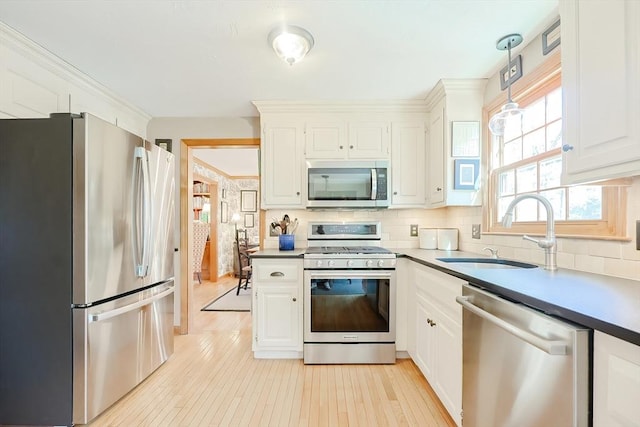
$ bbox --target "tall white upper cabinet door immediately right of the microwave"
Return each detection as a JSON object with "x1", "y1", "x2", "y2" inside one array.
[{"x1": 391, "y1": 121, "x2": 426, "y2": 206}]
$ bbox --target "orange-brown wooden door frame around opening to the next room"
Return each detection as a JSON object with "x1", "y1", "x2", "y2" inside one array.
[{"x1": 178, "y1": 138, "x2": 264, "y2": 335}]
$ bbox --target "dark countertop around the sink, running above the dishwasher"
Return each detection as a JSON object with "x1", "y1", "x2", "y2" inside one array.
[{"x1": 396, "y1": 249, "x2": 640, "y2": 345}]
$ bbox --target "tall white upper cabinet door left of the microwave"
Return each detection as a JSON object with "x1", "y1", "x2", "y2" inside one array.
[{"x1": 260, "y1": 122, "x2": 304, "y2": 208}]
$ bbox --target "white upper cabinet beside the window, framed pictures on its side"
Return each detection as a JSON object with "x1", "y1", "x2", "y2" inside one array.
[{"x1": 427, "y1": 79, "x2": 487, "y2": 208}]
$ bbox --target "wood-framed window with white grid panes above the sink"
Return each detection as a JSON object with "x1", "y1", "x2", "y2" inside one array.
[{"x1": 485, "y1": 58, "x2": 626, "y2": 237}]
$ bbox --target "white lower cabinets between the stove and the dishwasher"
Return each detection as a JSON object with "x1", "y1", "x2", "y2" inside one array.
[{"x1": 407, "y1": 263, "x2": 465, "y2": 426}]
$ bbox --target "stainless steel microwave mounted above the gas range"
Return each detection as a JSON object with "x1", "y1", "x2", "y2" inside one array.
[{"x1": 307, "y1": 160, "x2": 391, "y2": 209}]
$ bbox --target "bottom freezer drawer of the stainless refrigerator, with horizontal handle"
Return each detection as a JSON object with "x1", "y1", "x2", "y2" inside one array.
[{"x1": 73, "y1": 281, "x2": 174, "y2": 424}]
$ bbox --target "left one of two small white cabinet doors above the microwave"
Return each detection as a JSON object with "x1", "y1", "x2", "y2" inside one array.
[{"x1": 305, "y1": 122, "x2": 348, "y2": 159}]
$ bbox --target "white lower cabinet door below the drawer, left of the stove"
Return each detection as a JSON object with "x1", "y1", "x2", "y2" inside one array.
[{"x1": 254, "y1": 285, "x2": 302, "y2": 350}]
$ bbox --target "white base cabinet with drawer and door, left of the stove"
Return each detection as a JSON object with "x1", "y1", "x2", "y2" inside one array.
[{"x1": 252, "y1": 258, "x2": 303, "y2": 359}]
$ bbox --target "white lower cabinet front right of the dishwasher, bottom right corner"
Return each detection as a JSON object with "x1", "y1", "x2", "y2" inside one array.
[{"x1": 593, "y1": 331, "x2": 640, "y2": 427}]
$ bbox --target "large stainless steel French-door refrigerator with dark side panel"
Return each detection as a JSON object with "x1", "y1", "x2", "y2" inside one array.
[{"x1": 0, "y1": 114, "x2": 175, "y2": 425}]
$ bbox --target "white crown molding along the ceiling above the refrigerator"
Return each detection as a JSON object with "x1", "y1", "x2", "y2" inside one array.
[{"x1": 0, "y1": 21, "x2": 151, "y2": 121}]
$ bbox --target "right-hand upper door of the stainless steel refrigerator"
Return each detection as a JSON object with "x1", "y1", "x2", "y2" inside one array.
[{"x1": 145, "y1": 141, "x2": 175, "y2": 284}]
